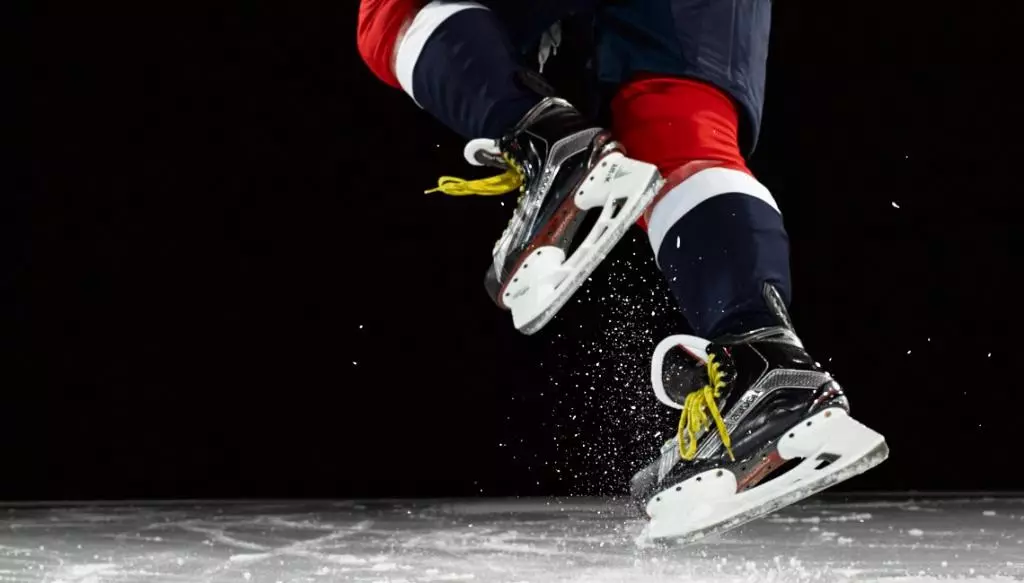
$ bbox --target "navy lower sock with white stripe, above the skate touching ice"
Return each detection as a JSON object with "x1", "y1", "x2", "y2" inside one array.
[{"x1": 647, "y1": 168, "x2": 791, "y2": 338}]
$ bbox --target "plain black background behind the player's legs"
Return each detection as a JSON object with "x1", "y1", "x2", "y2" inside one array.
[{"x1": 18, "y1": 1, "x2": 1024, "y2": 499}]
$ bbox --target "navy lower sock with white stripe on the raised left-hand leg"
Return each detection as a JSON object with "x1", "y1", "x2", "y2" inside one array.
[{"x1": 395, "y1": 1, "x2": 542, "y2": 139}]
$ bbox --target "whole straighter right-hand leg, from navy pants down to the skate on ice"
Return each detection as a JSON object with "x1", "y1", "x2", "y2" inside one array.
[{"x1": 599, "y1": 0, "x2": 888, "y2": 540}]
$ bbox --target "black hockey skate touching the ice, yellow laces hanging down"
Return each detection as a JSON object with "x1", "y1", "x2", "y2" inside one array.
[{"x1": 631, "y1": 286, "x2": 889, "y2": 544}]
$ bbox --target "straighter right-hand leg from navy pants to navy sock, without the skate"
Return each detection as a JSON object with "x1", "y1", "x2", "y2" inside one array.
[{"x1": 600, "y1": 0, "x2": 791, "y2": 337}]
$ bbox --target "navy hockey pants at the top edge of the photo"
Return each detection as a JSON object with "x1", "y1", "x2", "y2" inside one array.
[{"x1": 478, "y1": 0, "x2": 771, "y2": 155}]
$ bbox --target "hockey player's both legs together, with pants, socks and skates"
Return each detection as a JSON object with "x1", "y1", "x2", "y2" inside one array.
[{"x1": 357, "y1": 0, "x2": 889, "y2": 544}]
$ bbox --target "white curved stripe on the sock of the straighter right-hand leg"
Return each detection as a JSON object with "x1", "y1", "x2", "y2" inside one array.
[{"x1": 647, "y1": 168, "x2": 781, "y2": 258}]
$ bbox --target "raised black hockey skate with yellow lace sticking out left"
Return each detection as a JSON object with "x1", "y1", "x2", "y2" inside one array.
[{"x1": 430, "y1": 97, "x2": 662, "y2": 334}]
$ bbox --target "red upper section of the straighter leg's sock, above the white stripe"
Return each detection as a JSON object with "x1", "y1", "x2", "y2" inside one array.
[{"x1": 611, "y1": 75, "x2": 751, "y2": 230}]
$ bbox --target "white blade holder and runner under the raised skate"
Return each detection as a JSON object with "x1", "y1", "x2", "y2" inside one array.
[{"x1": 502, "y1": 151, "x2": 662, "y2": 334}]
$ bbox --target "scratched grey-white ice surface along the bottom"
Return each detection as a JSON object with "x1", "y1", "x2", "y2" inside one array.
[{"x1": 0, "y1": 496, "x2": 1024, "y2": 583}]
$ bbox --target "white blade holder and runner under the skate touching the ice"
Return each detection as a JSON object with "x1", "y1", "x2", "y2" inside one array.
[{"x1": 641, "y1": 408, "x2": 889, "y2": 544}]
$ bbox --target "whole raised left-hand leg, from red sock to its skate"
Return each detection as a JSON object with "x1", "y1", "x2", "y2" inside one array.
[{"x1": 359, "y1": 0, "x2": 658, "y2": 333}]
